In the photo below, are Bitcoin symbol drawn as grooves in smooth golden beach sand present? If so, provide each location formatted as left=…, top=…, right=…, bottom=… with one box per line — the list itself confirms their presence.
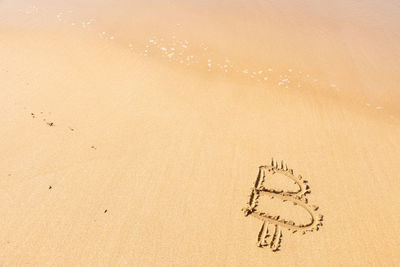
left=242, top=159, right=323, bottom=252
